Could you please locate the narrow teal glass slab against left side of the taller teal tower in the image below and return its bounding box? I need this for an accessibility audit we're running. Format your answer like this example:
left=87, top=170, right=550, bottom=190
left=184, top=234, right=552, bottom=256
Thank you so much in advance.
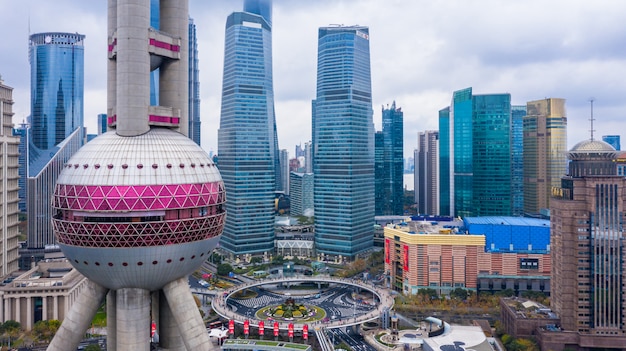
left=438, top=107, right=454, bottom=216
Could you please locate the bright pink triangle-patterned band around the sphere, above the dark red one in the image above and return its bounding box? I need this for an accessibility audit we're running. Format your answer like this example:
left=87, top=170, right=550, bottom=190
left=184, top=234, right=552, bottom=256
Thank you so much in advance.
left=52, top=182, right=225, bottom=211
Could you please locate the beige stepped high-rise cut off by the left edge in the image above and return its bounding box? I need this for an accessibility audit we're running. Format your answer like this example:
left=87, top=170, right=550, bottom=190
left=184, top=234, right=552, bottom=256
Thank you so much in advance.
left=0, top=77, right=20, bottom=276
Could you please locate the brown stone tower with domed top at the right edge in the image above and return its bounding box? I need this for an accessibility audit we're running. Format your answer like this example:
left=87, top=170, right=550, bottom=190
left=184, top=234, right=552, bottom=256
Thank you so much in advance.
left=544, top=140, right=626, bottom=350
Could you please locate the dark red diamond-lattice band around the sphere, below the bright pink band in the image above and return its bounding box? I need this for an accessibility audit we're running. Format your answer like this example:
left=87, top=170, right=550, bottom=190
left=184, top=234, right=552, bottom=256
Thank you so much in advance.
left=52, top=213, right=226, bottom=248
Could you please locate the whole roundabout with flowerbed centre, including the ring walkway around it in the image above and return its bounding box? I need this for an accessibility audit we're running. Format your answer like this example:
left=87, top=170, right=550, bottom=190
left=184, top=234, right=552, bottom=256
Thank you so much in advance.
left=211, top=275, right=394, bottom=331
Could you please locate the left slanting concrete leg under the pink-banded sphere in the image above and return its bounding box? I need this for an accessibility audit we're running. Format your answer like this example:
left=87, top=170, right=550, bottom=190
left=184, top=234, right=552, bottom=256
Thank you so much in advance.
left=48, top=280, right=109, bottom=351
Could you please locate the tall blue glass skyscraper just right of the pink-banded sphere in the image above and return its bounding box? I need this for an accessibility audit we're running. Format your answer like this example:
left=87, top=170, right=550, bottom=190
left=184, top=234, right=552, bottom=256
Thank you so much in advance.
left=218, top=0, right=282, bottom=255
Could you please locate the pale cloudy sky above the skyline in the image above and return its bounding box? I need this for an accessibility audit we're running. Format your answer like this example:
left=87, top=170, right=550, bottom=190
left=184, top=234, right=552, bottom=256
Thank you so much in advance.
left=0, top=0, right=626, bottom=160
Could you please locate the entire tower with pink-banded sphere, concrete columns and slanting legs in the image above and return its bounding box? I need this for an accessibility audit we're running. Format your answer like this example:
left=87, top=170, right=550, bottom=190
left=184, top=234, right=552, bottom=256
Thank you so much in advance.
left=48, top=0, right=226, bottom=351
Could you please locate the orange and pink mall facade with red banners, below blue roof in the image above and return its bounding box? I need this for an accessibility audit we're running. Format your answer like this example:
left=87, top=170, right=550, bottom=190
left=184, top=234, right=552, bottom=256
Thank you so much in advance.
left=384, top=221, right=551, bottom=294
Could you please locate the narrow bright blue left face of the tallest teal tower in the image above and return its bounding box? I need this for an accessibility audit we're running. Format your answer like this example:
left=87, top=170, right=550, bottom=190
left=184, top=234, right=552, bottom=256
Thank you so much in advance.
left=450, top=88, right=474, bottom=217
